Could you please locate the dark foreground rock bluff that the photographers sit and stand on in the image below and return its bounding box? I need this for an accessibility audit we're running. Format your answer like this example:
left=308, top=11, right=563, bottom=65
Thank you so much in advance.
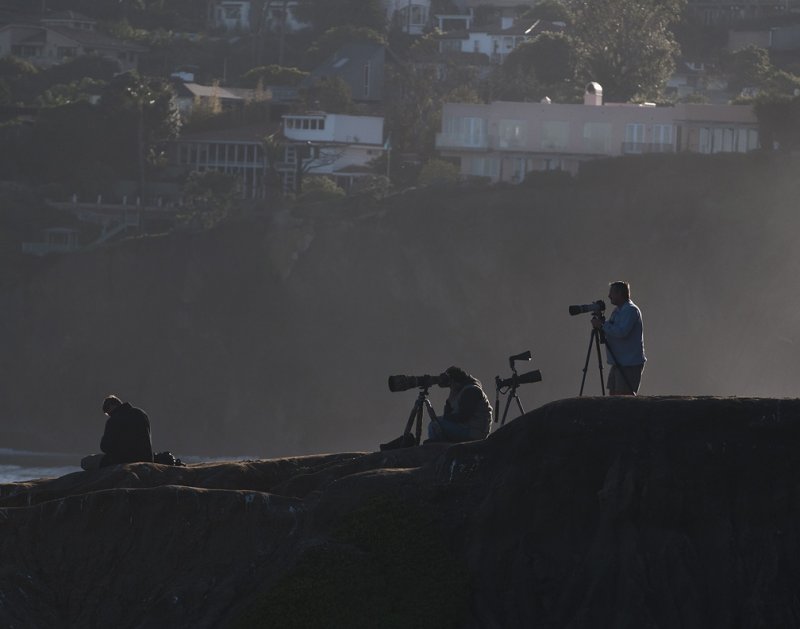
left=0, top=397, right=800, bottom=629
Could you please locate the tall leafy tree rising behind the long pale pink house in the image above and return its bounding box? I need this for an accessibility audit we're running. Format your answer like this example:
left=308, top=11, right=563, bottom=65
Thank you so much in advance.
left=569, top=0, right=684, bottom=102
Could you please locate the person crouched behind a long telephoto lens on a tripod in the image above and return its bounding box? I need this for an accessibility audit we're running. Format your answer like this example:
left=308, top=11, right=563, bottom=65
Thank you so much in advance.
left=428, top=367, right=492, bottom=442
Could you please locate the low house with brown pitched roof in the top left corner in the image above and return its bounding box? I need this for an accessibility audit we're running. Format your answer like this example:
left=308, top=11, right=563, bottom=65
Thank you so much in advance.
left=0, top=11, right=147, bottom=72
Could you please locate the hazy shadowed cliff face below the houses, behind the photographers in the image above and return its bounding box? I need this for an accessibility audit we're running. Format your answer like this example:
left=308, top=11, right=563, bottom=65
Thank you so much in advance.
left=0, top=158, right=800, bottom=457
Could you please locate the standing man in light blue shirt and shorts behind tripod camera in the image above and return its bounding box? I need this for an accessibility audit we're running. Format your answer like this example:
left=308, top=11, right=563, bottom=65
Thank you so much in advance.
left=592, top=282, right=647, bottom=395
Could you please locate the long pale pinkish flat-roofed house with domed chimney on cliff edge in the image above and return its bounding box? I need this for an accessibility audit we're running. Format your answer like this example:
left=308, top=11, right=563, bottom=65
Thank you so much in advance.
left=436, top=83, right=759, bottom=182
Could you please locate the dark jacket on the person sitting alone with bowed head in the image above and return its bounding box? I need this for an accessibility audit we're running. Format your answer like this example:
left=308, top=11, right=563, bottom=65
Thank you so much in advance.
left=100, top=402, right=153, bottom=467
